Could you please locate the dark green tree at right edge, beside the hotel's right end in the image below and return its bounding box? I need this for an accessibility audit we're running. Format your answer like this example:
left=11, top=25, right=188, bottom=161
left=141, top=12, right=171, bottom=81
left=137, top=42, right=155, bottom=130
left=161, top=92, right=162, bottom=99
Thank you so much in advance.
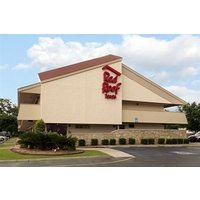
left=179, top=102, right=200, bottom=132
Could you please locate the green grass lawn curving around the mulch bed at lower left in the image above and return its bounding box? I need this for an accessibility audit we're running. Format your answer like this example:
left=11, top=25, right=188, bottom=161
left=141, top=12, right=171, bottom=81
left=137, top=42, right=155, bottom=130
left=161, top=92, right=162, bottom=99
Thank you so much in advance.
left=0, top=138, right=107, bottom=161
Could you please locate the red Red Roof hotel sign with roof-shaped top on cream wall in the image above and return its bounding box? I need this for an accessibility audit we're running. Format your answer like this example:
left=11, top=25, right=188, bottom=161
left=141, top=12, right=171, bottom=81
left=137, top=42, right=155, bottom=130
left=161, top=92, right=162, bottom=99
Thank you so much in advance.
left=102, top=65, right=122, bottom=99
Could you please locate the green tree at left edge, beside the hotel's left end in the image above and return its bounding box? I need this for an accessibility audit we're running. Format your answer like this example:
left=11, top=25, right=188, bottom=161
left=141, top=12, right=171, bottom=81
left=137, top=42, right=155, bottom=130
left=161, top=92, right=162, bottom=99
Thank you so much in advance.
left=0, top=98, right=18, bottom=133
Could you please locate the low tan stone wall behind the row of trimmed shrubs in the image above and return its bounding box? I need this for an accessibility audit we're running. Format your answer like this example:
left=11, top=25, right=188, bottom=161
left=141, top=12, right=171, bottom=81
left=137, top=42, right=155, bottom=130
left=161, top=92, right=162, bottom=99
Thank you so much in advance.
left=72, top=129, right=187, bottom=145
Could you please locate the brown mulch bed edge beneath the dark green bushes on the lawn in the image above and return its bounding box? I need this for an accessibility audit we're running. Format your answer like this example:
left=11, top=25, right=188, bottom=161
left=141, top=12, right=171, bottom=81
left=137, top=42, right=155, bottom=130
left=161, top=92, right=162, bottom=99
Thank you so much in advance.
left=11, top=146, right=84, bottom=156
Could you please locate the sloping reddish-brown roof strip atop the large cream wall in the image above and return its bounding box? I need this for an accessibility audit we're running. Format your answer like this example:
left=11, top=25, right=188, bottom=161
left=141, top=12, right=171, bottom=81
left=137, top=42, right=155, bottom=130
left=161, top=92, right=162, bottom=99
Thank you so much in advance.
left=38, top=54, right=122, bottom=81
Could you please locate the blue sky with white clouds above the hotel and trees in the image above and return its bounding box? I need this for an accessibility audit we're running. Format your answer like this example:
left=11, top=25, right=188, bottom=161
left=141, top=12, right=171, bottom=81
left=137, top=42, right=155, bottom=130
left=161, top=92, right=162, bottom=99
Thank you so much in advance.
left=0, top=34, right=200, bottom=103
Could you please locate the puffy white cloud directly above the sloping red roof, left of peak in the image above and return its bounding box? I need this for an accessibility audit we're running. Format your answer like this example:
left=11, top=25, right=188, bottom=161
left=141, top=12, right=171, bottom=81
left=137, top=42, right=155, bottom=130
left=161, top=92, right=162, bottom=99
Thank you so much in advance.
left=13, top=37, right=119, bottom=71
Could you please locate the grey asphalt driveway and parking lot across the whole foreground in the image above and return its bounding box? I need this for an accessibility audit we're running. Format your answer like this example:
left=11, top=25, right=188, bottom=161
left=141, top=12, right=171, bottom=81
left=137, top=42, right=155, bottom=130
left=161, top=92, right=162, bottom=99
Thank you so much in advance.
left=0, top=145, right=200, bottom=167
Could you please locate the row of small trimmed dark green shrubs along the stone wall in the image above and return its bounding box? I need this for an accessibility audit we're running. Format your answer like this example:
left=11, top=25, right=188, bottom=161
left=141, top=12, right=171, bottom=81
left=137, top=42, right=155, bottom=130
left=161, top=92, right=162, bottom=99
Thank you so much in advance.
left=78, top=138, right=189, bottom=146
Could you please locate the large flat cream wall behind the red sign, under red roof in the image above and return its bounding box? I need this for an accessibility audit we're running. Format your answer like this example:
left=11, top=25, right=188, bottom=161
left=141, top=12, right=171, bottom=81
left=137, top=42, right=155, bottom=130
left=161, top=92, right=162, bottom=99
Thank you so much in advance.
left=41, top=62, right=122, bottom=124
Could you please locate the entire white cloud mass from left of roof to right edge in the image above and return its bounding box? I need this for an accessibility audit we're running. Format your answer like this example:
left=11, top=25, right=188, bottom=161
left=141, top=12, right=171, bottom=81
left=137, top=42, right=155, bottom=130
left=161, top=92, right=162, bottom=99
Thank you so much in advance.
left=13, top=35, right=200, bottom=103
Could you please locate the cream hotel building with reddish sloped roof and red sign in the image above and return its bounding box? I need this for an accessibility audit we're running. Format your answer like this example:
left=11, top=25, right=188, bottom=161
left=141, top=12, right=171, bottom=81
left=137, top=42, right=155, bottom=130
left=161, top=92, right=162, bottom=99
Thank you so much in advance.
left=18, top=55, right=187, bottom=141
